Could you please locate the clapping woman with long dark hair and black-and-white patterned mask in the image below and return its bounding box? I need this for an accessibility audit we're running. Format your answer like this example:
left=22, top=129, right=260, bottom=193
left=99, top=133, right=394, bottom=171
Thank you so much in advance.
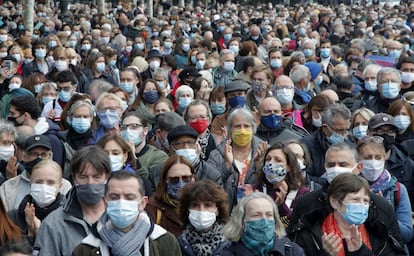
left=245, top=143, right=310, bottom=226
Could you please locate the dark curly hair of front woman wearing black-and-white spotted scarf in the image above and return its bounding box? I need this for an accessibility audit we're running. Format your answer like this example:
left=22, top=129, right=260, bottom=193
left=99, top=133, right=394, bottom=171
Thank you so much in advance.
left=179, top=180, right=229, bottom=225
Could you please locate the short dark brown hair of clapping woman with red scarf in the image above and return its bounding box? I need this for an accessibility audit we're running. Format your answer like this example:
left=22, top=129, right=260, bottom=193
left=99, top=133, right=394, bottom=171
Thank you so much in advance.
left=326, top=173, right=370, bottom=205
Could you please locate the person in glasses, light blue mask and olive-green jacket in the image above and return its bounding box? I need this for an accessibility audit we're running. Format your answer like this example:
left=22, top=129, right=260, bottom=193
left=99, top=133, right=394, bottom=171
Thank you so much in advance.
left=121, top=112, right=168, bottom=177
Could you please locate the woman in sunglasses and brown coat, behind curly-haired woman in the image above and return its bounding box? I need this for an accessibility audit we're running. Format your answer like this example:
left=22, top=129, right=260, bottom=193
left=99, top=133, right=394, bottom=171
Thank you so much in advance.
left=145, top=154, right=195, bottom=236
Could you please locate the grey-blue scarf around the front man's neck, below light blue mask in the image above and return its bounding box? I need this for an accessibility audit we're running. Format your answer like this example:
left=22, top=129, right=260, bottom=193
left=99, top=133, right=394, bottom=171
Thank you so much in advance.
left=98, top=211, right=151, bottom=256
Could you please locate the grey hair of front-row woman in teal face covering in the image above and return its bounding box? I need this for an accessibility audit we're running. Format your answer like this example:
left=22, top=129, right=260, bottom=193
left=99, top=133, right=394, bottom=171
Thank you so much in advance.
left=223, top=192, right=286, bottom=242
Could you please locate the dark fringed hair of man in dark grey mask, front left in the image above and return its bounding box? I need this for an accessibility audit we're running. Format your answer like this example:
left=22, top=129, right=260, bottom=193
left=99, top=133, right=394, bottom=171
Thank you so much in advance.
left=70, top=146, right=111, bottom=178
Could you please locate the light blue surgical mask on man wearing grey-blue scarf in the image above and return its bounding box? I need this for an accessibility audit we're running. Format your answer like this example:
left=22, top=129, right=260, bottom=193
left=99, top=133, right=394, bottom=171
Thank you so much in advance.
left=106, top=199, right=139, bottom=228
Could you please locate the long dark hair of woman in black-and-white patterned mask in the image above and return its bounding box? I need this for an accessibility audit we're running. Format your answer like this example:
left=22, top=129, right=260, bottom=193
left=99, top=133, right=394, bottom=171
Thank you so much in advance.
left=256, top=143, right=305, bottom=190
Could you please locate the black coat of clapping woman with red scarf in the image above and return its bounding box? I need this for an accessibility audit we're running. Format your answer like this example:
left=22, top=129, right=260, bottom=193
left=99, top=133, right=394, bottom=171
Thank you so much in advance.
left=287, top=187, right=405, bottom=256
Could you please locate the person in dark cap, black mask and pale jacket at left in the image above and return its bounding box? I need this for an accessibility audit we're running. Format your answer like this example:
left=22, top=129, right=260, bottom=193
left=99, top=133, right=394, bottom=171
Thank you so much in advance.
left=0, top=135, right=72, bottom=211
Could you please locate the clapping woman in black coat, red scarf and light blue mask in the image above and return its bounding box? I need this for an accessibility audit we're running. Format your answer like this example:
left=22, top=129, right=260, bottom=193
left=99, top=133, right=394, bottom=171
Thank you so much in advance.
left=288, top=173, right=406, bottom=255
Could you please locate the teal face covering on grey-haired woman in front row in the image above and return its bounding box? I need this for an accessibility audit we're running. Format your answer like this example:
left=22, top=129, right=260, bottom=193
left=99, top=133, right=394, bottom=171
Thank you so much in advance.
left=240, top=218, right=276, bottom=255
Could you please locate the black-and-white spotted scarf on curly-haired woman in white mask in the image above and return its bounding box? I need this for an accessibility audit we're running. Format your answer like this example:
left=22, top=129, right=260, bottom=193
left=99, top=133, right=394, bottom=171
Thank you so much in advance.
left=184, top=222, right=223, bottom=256
